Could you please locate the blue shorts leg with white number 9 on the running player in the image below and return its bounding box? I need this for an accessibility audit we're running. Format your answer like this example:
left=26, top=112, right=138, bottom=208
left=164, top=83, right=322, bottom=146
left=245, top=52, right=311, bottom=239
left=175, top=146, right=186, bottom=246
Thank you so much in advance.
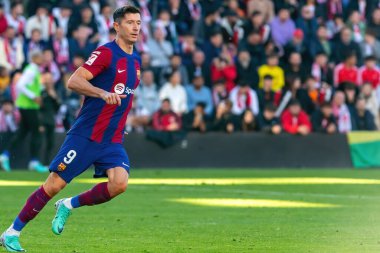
left=49, top=135, right=98, bottom=183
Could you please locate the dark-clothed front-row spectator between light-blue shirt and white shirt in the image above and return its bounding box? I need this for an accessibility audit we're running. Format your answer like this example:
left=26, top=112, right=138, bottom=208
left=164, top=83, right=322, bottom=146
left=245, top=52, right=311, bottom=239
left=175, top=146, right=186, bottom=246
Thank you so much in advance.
left=213, top=100, right=240, bottom=133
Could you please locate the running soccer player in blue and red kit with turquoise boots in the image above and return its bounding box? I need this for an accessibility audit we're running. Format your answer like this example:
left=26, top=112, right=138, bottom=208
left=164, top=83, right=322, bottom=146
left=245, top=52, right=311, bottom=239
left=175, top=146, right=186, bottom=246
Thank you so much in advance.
left=0, top=6, right=141, bottom=252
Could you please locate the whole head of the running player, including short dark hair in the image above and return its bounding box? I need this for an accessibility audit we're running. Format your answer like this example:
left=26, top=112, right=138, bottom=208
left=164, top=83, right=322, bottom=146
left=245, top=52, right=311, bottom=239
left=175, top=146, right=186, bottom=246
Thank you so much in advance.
left=113, top=5, right=141, bottom=44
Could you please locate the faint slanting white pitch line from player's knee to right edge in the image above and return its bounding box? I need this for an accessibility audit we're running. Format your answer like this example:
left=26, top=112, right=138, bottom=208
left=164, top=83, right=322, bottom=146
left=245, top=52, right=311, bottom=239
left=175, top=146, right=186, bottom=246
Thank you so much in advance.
left=130, top=185, right=380, bottom=200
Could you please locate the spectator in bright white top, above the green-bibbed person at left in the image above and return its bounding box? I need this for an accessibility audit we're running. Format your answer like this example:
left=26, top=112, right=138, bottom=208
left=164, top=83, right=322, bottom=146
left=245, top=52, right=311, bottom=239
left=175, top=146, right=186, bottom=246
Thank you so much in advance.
left=25, top=4, right=56, bottom=42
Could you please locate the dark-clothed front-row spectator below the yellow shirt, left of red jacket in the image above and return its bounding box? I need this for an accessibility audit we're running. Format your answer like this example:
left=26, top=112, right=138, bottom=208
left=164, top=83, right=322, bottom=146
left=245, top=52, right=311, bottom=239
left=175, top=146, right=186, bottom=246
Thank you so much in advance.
left=257, top=103, right=282, bottom=135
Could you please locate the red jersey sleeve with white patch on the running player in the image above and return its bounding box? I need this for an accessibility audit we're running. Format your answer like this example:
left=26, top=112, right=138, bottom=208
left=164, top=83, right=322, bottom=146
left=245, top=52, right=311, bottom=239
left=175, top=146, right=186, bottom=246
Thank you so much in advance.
left=82, top=46, right=112, bottom=77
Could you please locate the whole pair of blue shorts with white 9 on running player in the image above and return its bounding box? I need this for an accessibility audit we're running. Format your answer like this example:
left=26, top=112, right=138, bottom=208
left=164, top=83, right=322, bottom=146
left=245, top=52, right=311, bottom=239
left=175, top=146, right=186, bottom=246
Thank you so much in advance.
left=49, top=134, right=130, bottom=183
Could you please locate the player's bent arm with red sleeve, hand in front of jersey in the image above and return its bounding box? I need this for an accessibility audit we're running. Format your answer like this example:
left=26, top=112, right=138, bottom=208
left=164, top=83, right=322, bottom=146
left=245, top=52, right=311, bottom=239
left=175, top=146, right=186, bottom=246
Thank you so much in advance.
left=67, top=47, right=126, bottom=105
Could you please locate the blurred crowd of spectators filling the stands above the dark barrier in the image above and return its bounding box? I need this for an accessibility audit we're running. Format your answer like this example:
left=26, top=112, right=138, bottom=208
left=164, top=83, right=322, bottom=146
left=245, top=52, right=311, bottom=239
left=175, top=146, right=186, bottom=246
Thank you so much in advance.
left=0, top=0, right=380, bottom=142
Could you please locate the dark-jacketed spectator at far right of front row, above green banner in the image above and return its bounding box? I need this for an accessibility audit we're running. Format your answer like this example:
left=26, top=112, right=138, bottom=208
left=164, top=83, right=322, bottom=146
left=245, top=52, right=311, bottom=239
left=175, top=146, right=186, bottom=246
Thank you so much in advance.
left=353, top=97, right=376, bottom=131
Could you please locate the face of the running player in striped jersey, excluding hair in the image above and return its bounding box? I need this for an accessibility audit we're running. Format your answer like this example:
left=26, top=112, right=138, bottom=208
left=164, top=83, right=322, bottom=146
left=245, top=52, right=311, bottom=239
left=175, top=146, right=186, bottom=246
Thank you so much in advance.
left=114, top=13, right=141, bottom=44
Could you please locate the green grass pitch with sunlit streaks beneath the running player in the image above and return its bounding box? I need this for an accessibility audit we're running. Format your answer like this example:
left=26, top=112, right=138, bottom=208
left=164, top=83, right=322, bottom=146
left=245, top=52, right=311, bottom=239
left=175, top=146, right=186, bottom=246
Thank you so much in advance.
left=0, top=169, right=380, bottom=253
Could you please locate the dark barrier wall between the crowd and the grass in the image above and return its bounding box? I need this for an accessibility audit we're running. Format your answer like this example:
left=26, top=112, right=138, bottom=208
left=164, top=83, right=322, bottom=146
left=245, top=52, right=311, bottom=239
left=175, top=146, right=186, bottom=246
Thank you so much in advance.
left=5, top=133, right=352, bottom=168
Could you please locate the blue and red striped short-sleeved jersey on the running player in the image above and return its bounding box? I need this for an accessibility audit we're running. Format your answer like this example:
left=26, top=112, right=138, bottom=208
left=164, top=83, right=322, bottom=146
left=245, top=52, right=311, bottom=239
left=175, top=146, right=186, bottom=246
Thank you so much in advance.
left=68, top=41, right=141, bottom=143
